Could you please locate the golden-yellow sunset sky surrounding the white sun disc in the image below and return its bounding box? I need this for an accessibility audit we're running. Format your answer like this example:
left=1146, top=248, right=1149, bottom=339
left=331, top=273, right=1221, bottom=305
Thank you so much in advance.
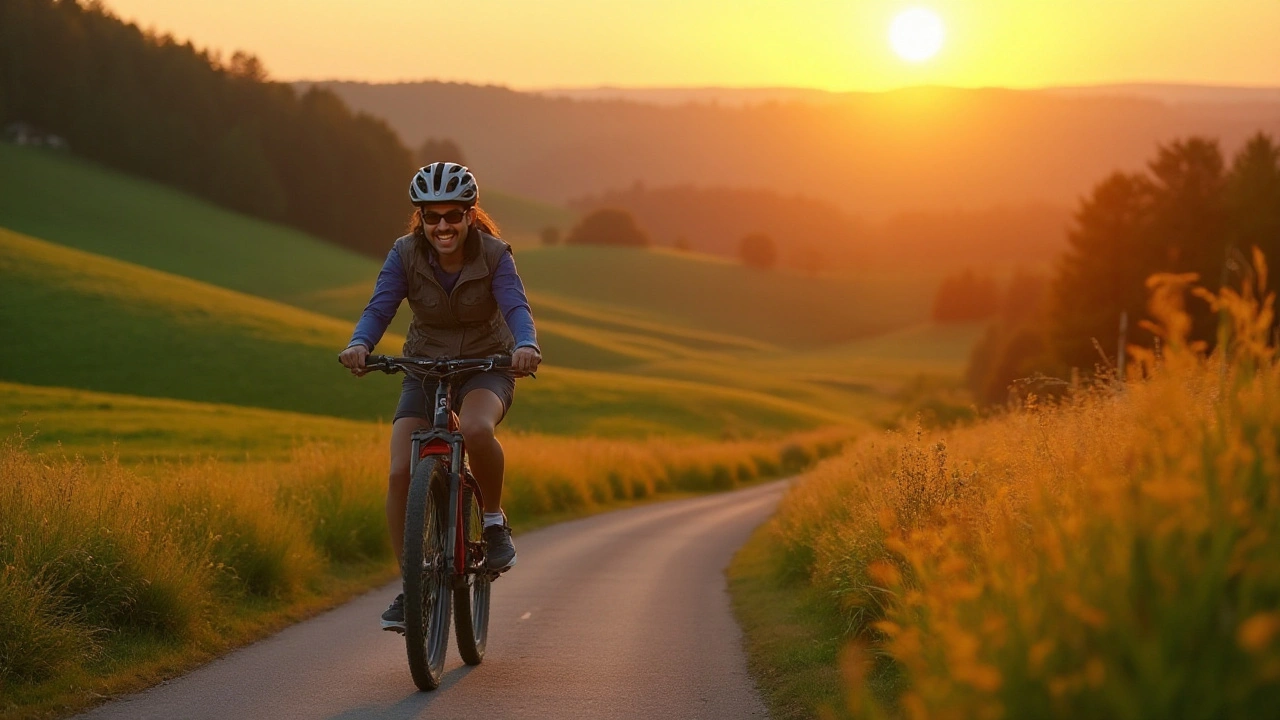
left=105, top=0, right=1280, bottom=91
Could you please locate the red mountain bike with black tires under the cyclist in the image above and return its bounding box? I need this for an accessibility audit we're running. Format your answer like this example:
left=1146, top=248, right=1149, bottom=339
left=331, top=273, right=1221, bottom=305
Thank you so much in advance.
left=365, top=355, right=511, bottom=691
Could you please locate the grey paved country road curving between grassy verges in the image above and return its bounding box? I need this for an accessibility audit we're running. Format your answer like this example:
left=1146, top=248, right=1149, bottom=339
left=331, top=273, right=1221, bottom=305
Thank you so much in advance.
left=82, top=483, right=785, bottom=720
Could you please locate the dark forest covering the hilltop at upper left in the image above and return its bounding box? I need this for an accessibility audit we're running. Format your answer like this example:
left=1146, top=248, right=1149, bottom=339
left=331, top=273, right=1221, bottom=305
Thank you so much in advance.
left=0, top=0, right=415, bottom=255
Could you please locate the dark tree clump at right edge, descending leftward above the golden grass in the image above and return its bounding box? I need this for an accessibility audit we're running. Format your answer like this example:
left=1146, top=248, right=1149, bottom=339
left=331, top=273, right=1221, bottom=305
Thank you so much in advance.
left=968, top=133, right=1280, bottom=404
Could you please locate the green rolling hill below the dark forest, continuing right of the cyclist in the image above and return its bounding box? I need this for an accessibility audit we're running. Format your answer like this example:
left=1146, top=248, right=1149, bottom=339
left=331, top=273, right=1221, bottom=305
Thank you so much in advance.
left=0, top=143, right=936, bottom=353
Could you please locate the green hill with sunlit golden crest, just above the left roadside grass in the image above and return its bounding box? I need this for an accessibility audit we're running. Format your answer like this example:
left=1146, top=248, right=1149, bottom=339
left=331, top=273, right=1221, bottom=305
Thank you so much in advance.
left=0, top=231, right=833, bottom=437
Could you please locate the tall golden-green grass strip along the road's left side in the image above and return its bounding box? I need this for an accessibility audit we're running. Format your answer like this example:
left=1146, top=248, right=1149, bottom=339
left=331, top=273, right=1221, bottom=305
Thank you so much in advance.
left=0, top=422, right=847, bottom=688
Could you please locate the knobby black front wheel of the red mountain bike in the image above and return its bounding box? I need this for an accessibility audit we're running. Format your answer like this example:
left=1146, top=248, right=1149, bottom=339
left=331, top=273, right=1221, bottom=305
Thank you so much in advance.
left=402, top=460, right=453, bottom=691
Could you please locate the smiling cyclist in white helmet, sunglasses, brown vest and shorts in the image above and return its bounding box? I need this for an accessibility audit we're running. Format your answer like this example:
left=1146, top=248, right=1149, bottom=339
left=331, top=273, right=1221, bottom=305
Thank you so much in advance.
left=339, top=163, right=541, bottom=630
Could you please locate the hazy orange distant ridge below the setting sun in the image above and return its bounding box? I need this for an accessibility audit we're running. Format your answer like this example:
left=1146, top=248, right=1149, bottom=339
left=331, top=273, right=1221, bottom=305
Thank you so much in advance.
left=296, top=82, right=1280, bottom=222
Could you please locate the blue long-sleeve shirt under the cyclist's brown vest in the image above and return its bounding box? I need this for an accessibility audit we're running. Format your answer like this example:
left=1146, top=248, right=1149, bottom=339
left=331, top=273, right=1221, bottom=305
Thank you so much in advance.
left=347, top=247, right=538, bottom=352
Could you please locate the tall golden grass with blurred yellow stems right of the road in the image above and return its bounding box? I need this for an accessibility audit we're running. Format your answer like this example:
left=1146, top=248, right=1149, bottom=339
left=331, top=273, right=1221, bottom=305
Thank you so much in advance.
left=774, top=249, right=1280, bottom=719
